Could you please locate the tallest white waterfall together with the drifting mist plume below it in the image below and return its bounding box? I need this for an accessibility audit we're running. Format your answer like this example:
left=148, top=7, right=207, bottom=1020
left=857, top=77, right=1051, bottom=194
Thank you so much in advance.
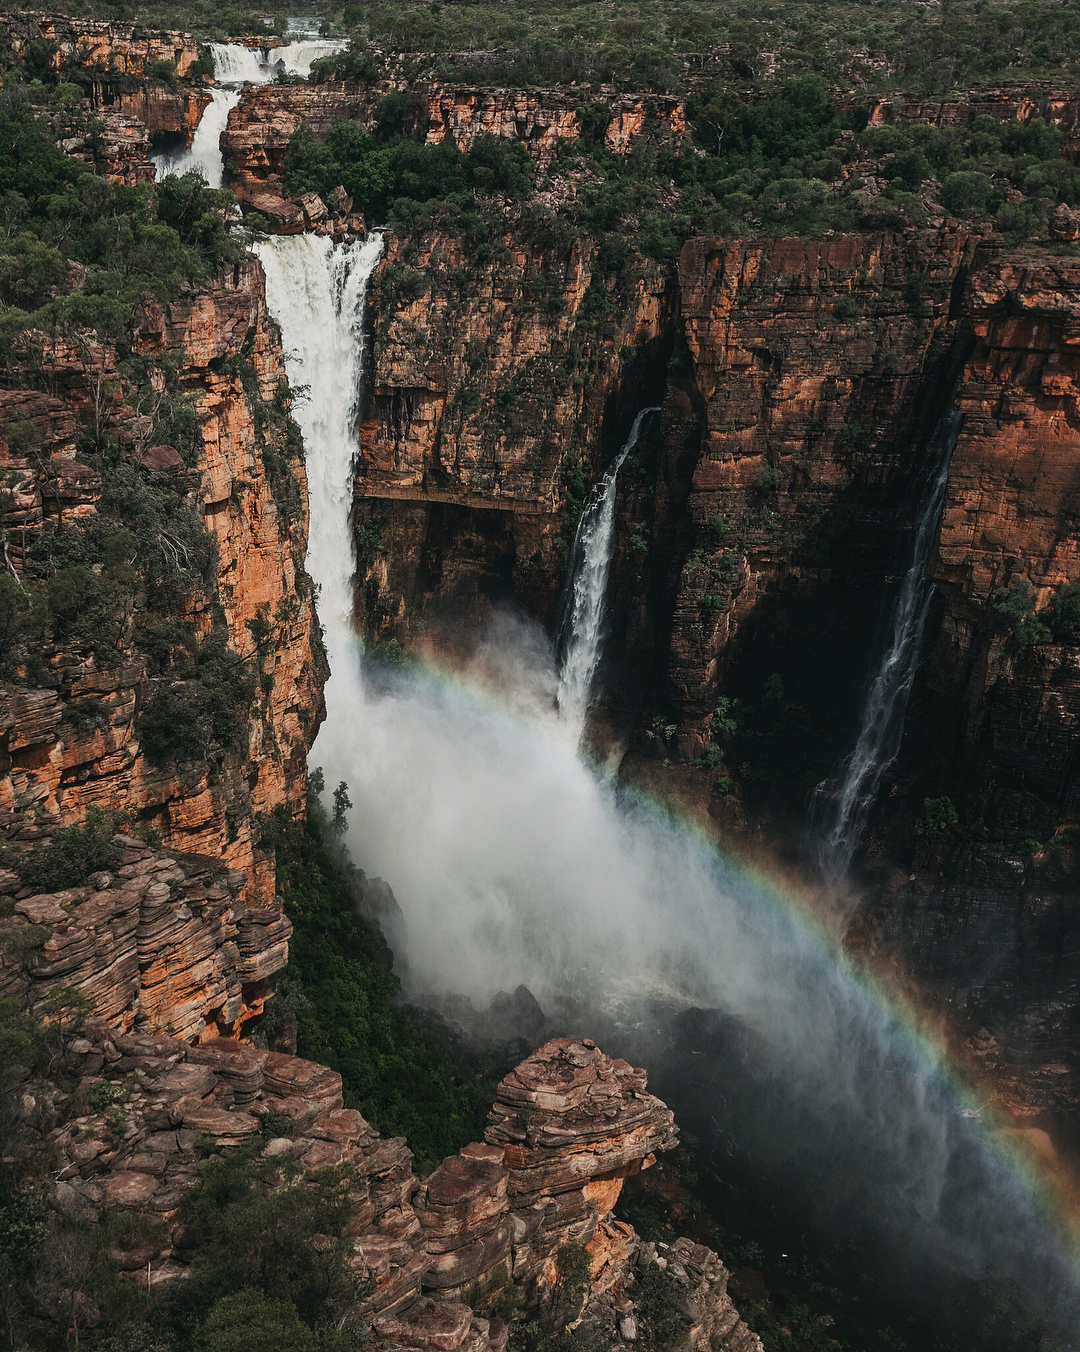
left=258, top=237, right=1076, bottom=1335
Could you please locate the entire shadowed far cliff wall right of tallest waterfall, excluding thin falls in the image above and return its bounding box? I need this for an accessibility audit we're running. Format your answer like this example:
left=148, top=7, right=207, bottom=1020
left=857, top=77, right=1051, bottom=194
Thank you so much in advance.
left=357, top=222, right=1080, bottom=1117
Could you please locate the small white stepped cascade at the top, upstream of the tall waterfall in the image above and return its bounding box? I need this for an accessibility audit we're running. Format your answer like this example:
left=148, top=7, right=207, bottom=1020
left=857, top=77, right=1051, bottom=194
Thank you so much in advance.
left=150, top=38, right=345, bottom=188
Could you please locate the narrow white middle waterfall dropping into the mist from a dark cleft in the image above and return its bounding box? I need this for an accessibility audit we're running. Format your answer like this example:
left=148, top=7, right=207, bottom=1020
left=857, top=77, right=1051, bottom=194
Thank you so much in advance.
left=557, top=406, right=660, bottom=741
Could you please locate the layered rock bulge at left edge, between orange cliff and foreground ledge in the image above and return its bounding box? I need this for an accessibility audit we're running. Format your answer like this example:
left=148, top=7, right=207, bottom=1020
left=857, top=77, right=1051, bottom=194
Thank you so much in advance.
left=0, top=813, right=292, bottom=1041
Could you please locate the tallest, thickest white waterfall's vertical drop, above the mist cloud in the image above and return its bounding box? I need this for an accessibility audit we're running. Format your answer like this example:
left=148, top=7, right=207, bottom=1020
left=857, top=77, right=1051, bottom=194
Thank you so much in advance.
left=254, top=233, right=383, bottom=779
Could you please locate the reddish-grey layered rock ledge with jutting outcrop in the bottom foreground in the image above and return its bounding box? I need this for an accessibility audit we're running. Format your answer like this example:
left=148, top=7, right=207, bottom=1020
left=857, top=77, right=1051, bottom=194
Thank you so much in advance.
left=24, top=1019, right=761, bottom=1352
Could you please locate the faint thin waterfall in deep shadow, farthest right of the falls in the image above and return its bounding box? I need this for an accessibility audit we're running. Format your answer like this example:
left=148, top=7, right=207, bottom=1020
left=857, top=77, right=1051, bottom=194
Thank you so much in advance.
left=815, top=412, right=961, bottom=882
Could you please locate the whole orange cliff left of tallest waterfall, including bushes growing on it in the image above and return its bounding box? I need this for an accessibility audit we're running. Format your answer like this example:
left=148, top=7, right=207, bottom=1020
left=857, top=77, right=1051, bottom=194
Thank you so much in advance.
left=0, top=258, right=323, bottom=896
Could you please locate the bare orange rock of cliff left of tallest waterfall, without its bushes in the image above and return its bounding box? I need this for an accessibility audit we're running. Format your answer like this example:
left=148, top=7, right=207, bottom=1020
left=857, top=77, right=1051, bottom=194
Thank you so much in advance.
left=0, top=260, right=323, bottom=898
